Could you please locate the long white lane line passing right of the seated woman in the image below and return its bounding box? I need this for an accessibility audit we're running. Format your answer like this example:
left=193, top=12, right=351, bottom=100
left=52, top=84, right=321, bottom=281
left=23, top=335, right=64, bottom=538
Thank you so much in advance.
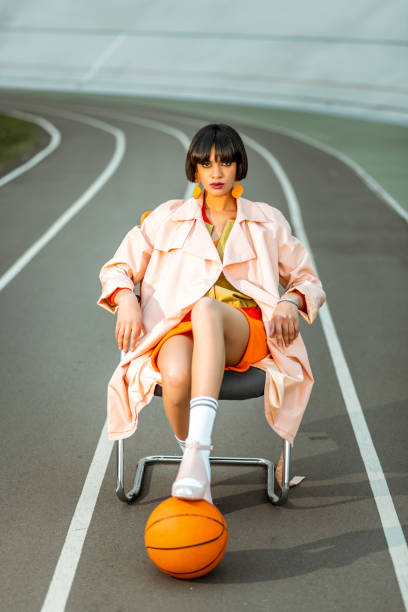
left=241, top=132, right=408, bottom=609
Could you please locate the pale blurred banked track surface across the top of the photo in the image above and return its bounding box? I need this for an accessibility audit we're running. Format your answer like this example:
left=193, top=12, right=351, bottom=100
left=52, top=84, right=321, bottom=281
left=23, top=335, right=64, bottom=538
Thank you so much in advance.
left=0, top=0, right=408, bottom=123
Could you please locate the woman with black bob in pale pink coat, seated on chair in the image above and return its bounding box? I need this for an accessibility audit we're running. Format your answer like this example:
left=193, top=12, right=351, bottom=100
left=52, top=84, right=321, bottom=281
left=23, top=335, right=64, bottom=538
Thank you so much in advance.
left=98, top=124, right=325, bottom=503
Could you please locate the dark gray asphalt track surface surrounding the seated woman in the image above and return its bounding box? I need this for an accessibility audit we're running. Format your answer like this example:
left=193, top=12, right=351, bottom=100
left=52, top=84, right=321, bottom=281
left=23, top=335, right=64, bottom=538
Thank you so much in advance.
left=0, top=94, right=408, bottom=612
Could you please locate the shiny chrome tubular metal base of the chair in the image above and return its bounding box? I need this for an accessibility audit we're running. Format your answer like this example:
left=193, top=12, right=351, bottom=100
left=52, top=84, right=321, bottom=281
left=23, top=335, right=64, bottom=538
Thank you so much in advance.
left=116, top=440, right=291, bottom=506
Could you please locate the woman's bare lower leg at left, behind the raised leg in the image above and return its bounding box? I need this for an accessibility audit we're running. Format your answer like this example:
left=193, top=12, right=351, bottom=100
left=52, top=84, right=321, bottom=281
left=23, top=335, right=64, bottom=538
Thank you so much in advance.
left=157, top=334, right=193, bottom=440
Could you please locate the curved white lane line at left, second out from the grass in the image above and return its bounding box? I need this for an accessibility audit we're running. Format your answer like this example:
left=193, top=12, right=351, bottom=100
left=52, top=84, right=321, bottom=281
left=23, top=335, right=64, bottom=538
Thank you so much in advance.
left=0, top=107, right=126, bottom=291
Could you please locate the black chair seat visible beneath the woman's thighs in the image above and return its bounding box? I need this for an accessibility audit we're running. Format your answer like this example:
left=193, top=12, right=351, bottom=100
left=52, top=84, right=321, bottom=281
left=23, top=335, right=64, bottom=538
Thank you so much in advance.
left=154, top=366, right=265, bottom=400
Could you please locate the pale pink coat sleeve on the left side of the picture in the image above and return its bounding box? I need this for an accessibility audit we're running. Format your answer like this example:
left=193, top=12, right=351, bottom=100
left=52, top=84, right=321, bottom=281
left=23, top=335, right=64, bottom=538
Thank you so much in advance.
left=97, top=219, right=153, bottom=313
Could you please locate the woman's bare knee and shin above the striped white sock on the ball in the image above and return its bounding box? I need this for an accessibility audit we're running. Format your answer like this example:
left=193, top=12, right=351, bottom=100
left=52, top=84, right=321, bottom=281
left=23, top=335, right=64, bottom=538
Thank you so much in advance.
left=191, top=297, right=249, bottom=398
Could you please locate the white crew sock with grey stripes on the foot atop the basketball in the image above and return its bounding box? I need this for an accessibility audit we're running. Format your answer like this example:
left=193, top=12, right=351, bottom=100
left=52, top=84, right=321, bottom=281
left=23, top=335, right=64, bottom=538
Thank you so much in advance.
left=186, top=395, right=218, bottom=482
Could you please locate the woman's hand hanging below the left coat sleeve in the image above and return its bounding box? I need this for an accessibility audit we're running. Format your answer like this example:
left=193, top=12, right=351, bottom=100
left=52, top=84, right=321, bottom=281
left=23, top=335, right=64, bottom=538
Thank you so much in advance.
left=115, top=289, right=143, bottom=353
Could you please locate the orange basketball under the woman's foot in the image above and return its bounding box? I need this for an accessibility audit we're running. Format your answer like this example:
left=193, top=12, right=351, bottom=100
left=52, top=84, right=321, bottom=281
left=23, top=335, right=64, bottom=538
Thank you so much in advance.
left=145, top=497, right=228, bottom=578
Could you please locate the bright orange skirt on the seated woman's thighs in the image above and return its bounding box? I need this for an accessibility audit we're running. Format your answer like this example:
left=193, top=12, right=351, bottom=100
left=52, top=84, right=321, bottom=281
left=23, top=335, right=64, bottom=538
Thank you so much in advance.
left=151, top=306, right=269, bottom=372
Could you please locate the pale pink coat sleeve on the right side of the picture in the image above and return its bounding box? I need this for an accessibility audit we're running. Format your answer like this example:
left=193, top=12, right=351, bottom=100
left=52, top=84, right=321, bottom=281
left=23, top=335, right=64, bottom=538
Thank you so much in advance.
left=279, top=214, right=326, bottom=324
